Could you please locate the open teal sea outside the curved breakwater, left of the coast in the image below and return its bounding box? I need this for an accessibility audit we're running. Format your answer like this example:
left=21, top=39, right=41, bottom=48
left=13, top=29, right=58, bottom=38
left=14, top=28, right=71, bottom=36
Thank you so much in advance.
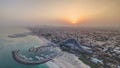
left=0, top=28, right=48, bottom=68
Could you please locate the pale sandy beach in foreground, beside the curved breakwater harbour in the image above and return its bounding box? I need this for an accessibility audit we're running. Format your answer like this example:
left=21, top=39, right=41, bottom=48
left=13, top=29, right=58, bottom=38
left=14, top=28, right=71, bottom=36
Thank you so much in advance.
left=46, top=52, right=90, bottom=68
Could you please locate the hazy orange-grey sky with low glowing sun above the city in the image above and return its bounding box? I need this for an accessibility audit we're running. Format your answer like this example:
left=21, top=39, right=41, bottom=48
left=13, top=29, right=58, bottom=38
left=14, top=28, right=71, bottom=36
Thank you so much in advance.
left=0, top=0, right=120, bottom=27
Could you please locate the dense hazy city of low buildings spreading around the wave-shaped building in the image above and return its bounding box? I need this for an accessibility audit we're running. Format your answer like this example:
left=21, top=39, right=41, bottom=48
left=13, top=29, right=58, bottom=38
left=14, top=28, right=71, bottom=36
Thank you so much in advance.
left=29, top=27, right=120, bottom=68
